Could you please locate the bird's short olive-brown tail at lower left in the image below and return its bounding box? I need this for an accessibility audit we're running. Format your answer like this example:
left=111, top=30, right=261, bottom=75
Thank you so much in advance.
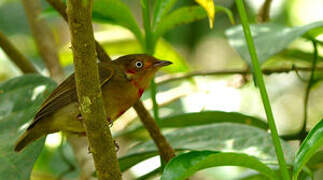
left=15, top=128, right=45, bottom=152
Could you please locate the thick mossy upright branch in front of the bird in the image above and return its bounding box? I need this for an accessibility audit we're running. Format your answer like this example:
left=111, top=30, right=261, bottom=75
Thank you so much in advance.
left=67, top=0, right=121, bottom=180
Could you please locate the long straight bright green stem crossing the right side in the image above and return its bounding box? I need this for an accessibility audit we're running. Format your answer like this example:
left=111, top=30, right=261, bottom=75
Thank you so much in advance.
left=235, top=0, right=290, bottom=180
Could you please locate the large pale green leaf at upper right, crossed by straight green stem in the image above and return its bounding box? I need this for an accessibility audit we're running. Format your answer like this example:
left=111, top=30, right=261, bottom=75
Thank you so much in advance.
left=226, top=21, right=323, bottom=64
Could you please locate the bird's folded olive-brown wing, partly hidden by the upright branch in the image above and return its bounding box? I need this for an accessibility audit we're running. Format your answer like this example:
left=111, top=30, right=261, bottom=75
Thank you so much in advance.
left=28, top=63, right=114, bottom=129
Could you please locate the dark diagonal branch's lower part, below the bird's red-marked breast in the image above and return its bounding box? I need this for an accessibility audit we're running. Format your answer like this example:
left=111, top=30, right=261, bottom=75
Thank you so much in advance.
left=133, top=101, right=175, bottom=162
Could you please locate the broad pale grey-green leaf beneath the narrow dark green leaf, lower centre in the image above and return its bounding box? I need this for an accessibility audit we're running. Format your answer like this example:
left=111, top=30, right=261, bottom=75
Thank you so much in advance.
left=120, top=123, right=294, bottom=170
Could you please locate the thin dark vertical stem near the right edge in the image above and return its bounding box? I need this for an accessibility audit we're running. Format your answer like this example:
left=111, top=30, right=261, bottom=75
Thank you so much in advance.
left=300, top=41, right=318, bottom=141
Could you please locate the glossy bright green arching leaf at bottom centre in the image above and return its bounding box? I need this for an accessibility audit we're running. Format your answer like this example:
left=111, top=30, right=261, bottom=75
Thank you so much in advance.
left=160, top=151, right=279, bottom=180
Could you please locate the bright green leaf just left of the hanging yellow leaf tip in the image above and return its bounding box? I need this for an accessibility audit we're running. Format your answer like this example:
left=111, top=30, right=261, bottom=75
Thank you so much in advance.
left=154, top=6, right=207, bottom=40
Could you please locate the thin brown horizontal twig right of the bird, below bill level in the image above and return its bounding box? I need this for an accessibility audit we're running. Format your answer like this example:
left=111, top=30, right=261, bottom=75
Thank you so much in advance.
left=156, top=66, right=323, bottom=85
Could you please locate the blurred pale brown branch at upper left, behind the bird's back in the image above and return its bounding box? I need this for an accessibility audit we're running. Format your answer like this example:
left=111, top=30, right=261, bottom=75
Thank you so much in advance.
left=22, top=0, right=64, bottom=82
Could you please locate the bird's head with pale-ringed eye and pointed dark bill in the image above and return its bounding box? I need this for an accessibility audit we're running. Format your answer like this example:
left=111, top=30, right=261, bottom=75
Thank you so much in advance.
left=115, top=54, right=172, bottom=89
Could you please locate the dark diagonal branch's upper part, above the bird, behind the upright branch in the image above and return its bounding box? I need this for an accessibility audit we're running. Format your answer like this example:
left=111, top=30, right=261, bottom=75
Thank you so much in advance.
left=47, top=0, right=111, bottom=62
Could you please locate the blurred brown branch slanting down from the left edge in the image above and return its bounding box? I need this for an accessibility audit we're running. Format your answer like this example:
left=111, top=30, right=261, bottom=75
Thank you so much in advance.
left=0, top=31, right=38, bottom=73
